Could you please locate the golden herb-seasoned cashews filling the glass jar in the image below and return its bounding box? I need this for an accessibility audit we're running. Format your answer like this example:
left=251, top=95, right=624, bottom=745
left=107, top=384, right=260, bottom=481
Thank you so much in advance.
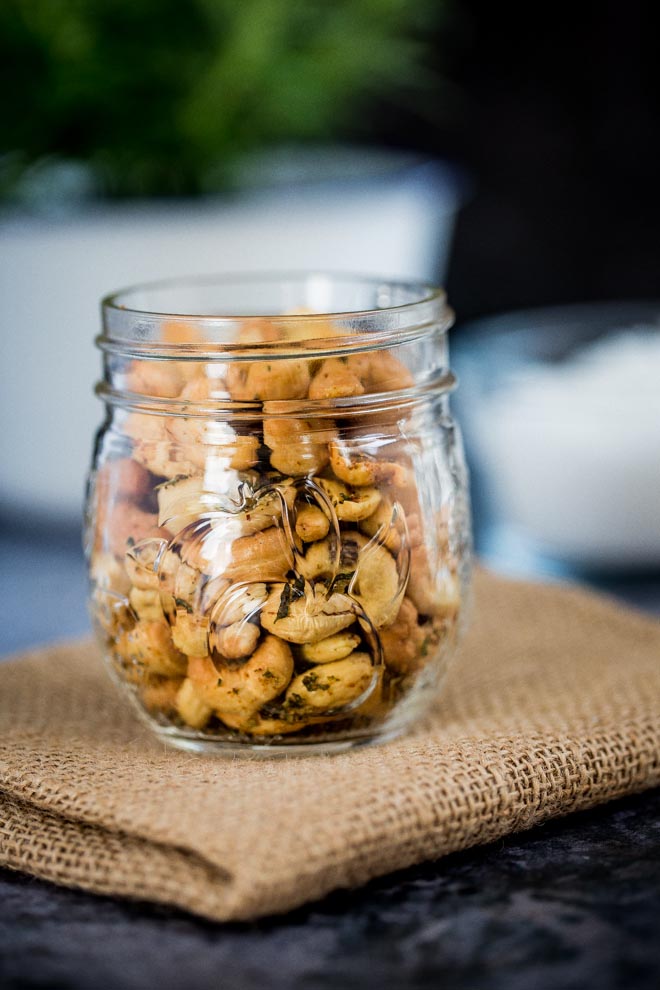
left=88, top=320, right=460, bottom=739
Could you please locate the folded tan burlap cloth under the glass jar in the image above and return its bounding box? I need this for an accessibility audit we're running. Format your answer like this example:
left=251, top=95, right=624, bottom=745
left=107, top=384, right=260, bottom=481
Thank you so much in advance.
left=0, top=574, right=660, bottom=919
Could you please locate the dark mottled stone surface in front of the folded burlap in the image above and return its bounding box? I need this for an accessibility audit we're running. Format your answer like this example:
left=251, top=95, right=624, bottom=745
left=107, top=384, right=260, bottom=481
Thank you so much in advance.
left=0, top=791, right=660, bottom=990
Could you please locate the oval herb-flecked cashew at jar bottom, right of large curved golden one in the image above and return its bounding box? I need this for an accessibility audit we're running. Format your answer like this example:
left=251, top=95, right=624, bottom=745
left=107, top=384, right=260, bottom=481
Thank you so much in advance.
left=284, top=653, right=374, bottom=712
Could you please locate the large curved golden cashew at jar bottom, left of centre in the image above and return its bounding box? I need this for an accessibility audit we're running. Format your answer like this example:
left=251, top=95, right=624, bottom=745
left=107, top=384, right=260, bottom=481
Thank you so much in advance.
left=188, top=636, right=293, bottom=718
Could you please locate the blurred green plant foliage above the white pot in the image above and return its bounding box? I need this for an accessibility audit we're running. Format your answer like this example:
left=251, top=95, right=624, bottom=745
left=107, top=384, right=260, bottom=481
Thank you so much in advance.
left=0, top=0, right=446, bottom=196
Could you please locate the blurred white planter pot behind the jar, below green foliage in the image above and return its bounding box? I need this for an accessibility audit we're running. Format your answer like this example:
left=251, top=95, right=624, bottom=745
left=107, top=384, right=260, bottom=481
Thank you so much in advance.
left=0, top=156, right=458, bottom=520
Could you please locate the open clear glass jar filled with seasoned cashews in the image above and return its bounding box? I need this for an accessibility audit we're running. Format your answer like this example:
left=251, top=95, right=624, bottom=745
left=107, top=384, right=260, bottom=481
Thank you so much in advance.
left=85, top=274, right=471, bottom=753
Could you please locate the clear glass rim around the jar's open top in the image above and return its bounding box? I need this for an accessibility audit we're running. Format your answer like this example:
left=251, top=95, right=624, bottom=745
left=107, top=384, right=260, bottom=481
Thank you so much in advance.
left=98, top=270, right=453, bottom=359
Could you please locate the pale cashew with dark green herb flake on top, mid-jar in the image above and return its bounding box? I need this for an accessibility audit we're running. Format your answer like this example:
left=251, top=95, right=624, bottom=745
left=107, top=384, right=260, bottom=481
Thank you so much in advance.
left=261, top=585, right=356, bottom=643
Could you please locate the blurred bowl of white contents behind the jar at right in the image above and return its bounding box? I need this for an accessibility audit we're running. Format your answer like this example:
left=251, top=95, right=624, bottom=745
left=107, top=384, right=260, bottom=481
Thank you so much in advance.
left=452, top=302, right=660, bottom=572
